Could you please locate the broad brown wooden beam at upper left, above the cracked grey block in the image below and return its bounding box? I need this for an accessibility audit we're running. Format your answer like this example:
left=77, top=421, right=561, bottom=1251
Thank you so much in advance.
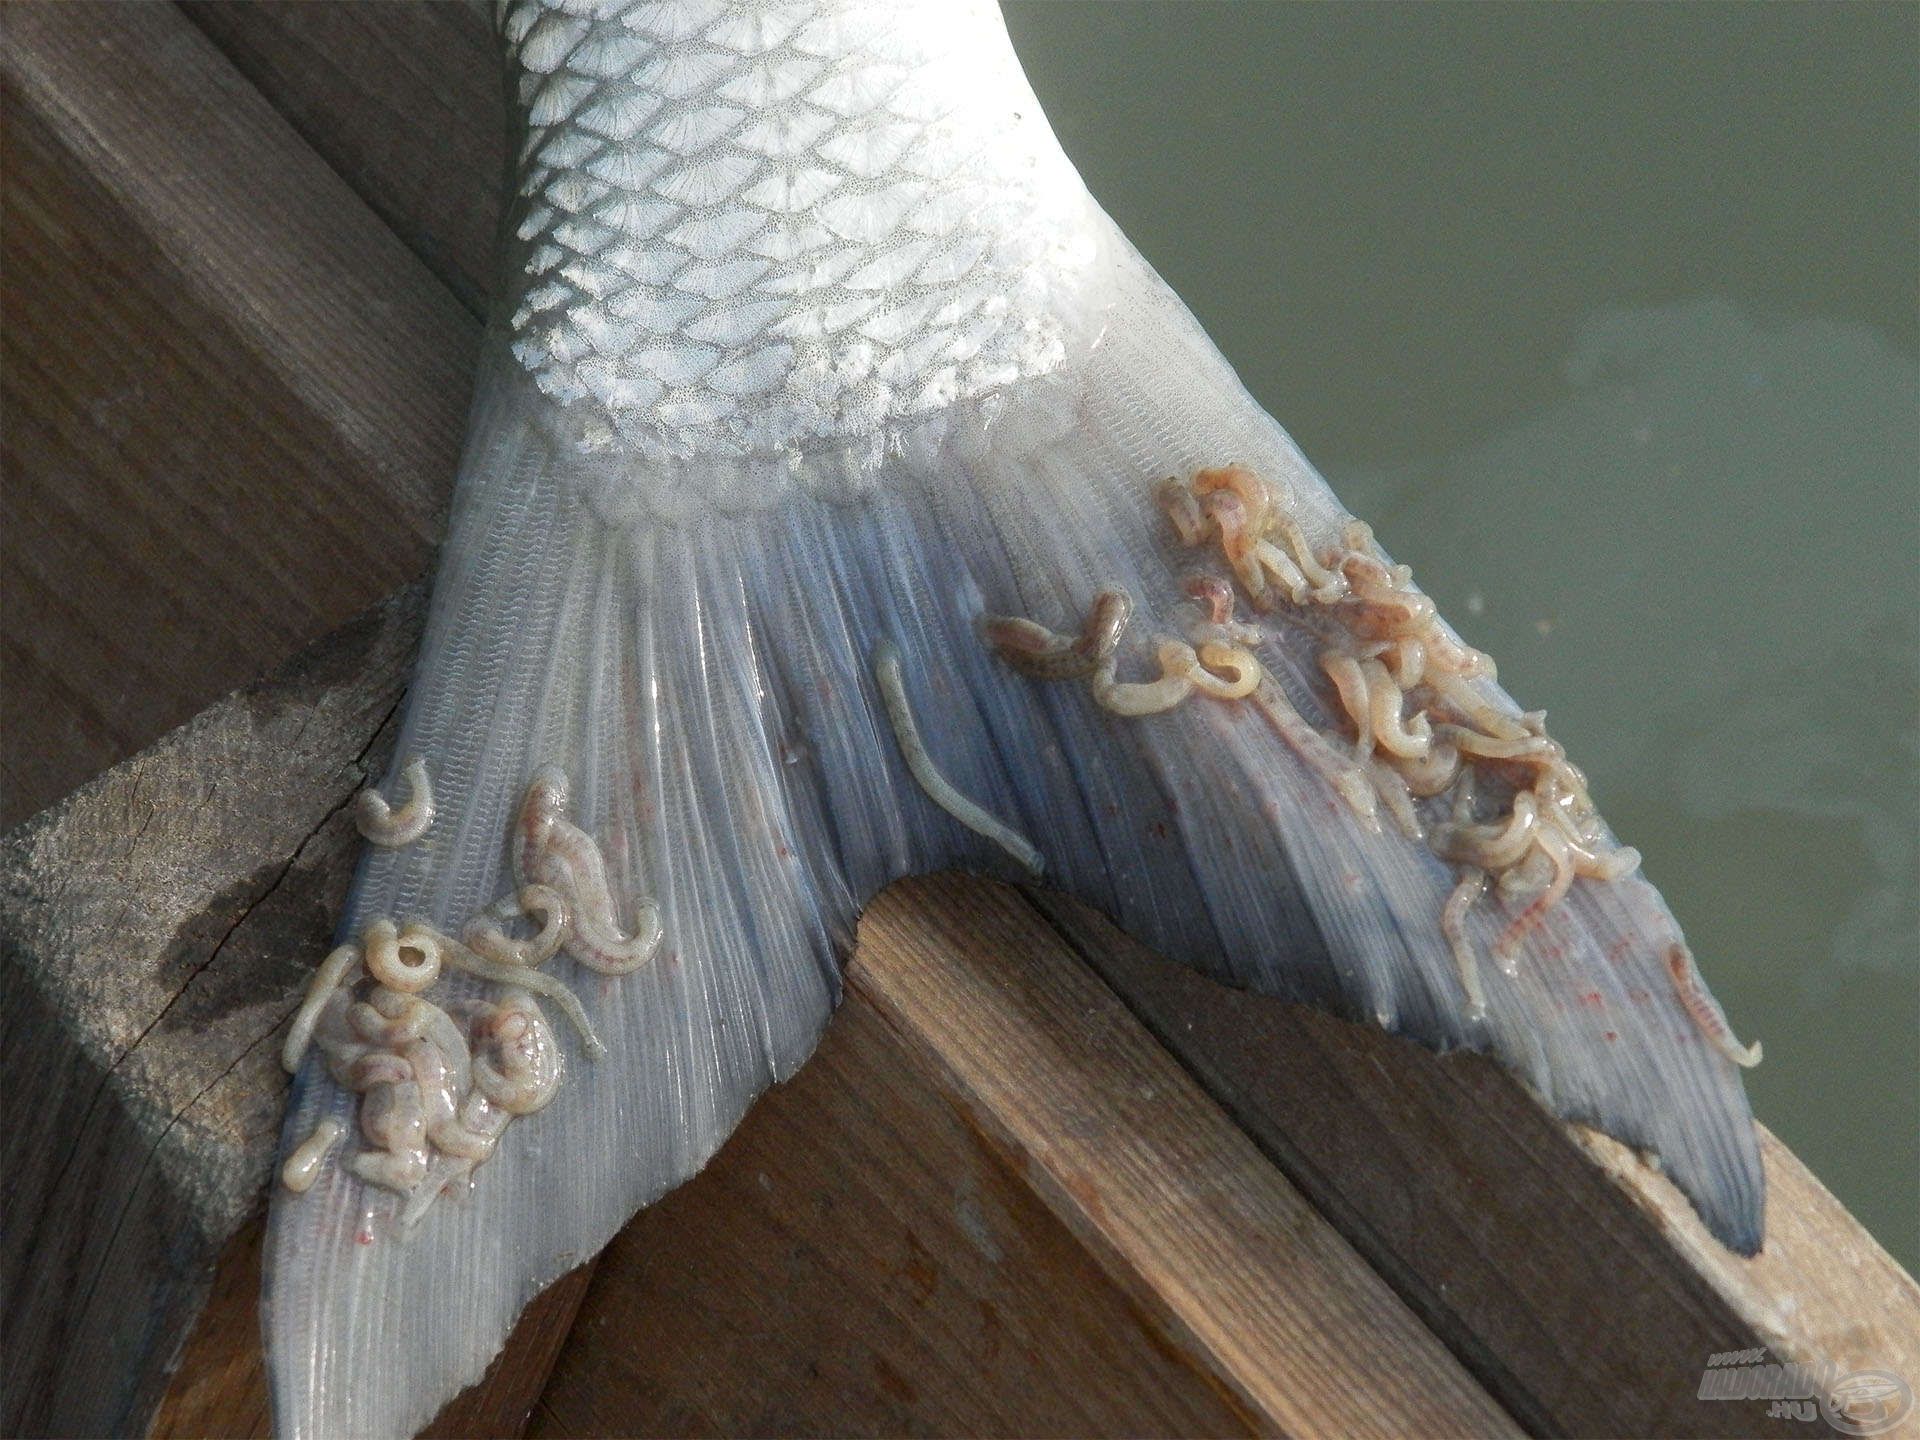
left=0, top=4, right=478, bottom=824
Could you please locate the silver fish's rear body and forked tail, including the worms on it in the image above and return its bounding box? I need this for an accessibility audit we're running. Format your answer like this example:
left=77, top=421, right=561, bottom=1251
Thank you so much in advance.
left=263, top=0, right=1764, bottom=1436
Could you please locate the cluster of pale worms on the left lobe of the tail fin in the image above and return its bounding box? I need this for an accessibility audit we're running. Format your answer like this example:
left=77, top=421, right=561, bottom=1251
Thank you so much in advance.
left=280, top=760, right=660, bottom=1225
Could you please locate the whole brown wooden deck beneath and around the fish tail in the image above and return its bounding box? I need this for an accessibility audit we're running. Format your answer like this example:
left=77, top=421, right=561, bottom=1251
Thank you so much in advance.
left=0, top=0, right=1920, bottom=1436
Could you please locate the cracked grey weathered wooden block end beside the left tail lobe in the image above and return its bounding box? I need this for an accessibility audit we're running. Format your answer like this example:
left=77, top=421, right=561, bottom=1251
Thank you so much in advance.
left=0, top=589, right=422, bottom=1434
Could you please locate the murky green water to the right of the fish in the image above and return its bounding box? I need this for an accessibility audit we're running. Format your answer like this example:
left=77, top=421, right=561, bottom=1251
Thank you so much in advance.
left=1008, top=0, right=1920, bottom=1269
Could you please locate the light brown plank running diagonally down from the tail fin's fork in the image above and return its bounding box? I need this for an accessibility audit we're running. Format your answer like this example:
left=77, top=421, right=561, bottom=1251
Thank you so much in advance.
left=851, top=876, right=1513, bottom=1436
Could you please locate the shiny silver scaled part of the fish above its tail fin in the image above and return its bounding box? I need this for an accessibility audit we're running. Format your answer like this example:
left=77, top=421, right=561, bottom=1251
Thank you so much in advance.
left=501, top=0, right=1091, bottom=455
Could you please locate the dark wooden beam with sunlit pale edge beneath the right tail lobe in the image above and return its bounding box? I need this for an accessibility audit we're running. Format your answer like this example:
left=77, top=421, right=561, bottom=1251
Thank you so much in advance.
left=1035, top=895, right=1920, bottom=1436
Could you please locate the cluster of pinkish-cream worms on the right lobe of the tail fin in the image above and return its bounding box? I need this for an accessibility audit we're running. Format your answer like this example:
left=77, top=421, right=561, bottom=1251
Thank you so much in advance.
left=983, top=465, right=1757, bottom=1064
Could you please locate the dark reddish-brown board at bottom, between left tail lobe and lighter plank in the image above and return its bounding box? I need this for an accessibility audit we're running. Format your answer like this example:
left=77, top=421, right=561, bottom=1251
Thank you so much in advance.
left=532, top=971, right=1260, bottom=1436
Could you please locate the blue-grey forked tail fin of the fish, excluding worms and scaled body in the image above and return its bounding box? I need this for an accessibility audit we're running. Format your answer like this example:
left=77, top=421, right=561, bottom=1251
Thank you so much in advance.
left=265, top=259, right=1763, bottom=1436
